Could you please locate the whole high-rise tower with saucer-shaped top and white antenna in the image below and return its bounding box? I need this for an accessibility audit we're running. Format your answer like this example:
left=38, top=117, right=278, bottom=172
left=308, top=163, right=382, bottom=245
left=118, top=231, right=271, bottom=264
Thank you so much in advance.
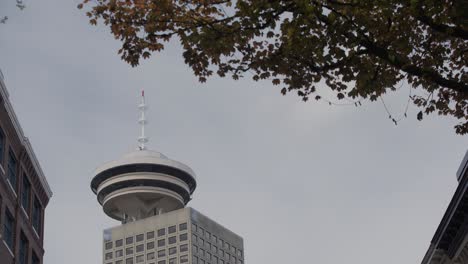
left=91, top=93, right=244, bottom=264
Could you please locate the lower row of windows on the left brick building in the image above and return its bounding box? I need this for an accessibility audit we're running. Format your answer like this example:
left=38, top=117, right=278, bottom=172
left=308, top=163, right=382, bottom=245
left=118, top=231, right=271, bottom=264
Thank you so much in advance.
left=0, top=197, right=40, bottom=264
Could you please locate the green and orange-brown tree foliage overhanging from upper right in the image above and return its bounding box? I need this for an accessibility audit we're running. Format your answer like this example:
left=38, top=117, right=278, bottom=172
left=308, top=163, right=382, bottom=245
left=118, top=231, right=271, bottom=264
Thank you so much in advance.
left=79, top=0, right=468, bottom=134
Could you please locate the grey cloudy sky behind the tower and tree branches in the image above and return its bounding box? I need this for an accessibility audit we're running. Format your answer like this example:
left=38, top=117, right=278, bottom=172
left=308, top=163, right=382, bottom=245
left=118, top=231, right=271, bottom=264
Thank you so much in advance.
left=0, top=0, right=468, bottom=264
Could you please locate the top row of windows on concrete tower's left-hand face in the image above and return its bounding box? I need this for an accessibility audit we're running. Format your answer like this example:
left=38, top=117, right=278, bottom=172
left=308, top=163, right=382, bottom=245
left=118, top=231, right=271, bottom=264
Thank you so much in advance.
left=104, top=223, right=187, bottom=250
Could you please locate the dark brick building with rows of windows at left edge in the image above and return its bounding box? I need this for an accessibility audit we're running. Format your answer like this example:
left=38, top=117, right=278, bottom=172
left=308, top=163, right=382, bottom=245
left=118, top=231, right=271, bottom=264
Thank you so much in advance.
left=0, top=73, right=52, bottom=264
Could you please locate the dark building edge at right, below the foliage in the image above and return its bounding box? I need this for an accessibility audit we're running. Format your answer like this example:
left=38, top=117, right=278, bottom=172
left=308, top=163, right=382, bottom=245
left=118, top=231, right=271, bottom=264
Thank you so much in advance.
left=422, top=151, right=468, bottom=264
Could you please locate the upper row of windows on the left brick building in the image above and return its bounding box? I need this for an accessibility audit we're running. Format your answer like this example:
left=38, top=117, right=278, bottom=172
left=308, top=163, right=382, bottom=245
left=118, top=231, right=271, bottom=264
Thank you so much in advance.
left=0, top=128, right=42, bottom=235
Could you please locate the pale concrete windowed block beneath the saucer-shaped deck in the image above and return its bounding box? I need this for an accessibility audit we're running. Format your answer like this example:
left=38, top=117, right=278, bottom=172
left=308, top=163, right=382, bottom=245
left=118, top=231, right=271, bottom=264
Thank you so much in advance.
left=103, top=207, right=244, bottom=264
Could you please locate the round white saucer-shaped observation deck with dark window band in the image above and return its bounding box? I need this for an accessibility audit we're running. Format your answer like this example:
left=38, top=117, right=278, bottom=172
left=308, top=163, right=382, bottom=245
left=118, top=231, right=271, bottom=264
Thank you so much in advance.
left=91, top=149, right=196, bottom=222
